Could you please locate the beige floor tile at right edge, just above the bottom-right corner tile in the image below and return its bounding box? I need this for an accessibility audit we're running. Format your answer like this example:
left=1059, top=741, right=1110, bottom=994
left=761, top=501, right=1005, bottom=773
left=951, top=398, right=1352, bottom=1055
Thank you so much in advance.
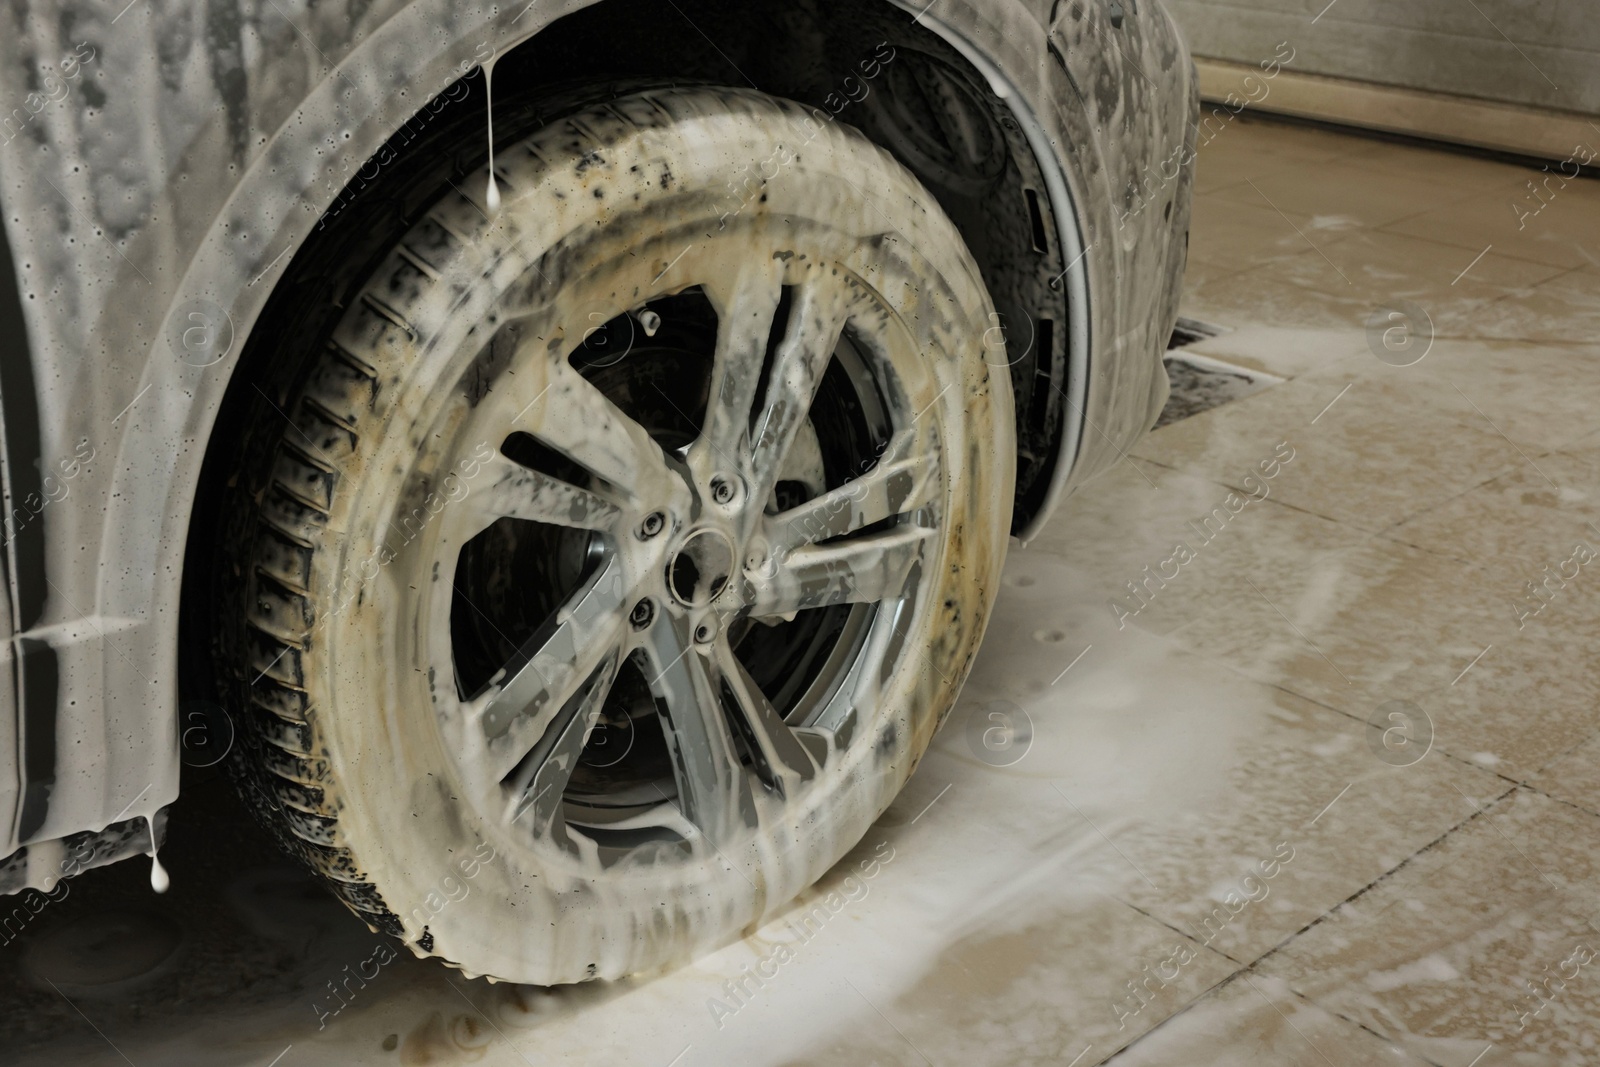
left=1138, top=492, right=1600, bottom=779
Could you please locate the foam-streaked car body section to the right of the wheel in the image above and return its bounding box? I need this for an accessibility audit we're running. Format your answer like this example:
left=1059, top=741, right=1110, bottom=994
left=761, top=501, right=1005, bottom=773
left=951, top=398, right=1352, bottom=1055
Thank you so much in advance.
left=893, top=0, right=1200, bottom=544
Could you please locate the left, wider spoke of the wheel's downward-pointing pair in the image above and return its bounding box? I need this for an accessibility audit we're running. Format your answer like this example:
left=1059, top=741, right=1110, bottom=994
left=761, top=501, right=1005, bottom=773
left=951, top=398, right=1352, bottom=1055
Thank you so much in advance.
left=645, top=616, right=755, bottom=845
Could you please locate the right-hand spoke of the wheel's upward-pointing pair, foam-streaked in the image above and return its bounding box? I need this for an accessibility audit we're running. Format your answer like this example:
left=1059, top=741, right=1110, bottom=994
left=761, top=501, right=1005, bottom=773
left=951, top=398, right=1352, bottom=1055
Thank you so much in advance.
left=750, top=277, right=848, bottom=511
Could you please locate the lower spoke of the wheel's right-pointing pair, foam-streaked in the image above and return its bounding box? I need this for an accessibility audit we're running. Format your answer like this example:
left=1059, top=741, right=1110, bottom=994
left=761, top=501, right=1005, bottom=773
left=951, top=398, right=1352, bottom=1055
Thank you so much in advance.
left=746, top=526, right=933, bottom=617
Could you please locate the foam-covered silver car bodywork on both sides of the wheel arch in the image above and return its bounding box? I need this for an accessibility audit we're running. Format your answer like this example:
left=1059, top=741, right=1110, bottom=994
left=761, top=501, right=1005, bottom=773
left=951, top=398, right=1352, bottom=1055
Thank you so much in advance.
left=0, top=0, right=1195, bottom=891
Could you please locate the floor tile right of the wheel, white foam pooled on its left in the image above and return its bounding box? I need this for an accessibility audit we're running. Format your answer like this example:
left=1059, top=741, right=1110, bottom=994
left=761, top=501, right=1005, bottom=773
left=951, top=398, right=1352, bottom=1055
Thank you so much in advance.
left=960, top=550, right=1510, bottom=963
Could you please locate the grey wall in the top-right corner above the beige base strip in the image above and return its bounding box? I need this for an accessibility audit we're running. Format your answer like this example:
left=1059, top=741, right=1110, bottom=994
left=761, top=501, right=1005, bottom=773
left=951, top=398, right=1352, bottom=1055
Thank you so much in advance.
left=1165, top=0, right=1600, bottom=115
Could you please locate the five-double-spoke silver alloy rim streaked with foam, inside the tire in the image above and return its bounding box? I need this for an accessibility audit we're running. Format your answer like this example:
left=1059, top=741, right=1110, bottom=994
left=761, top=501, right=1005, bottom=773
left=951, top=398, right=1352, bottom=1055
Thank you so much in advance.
left=400, top=235, right=944, bottom=867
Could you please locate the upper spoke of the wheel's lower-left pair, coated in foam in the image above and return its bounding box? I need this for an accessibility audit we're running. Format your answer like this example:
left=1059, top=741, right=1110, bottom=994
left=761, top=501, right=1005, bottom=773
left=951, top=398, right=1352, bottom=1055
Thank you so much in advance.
left=477, top=557, right=626, bottom=782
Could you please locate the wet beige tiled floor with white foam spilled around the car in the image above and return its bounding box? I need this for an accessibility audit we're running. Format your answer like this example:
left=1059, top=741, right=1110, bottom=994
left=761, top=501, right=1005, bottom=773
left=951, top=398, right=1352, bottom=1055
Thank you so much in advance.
left=12, top=118, right=1600, bottom=1067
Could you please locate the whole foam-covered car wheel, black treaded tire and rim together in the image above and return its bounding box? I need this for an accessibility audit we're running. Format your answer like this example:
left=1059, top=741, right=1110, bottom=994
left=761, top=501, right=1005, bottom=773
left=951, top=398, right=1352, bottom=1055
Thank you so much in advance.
left=219, top=88, right=1014, bottom=984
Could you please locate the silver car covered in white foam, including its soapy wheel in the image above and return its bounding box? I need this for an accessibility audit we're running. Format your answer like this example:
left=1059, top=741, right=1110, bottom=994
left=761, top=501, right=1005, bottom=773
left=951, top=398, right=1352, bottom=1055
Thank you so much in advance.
left=0, top=0, right=1198, bottom=984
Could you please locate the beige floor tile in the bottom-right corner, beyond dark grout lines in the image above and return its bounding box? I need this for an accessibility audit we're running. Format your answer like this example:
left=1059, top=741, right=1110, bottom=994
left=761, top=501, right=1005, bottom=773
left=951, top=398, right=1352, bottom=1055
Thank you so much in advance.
left=1261, top=790, right=1600, bottom=1067
